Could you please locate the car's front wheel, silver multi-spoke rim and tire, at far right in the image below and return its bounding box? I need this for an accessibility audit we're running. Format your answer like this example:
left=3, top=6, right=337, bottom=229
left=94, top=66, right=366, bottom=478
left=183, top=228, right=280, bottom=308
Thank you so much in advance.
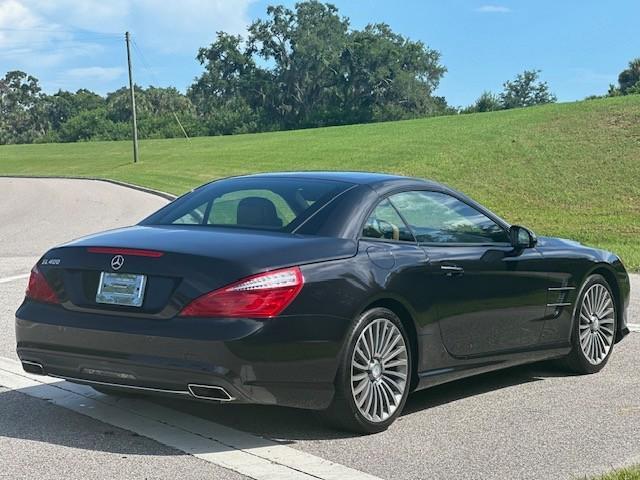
left=566, top=275, right=617, bottom=374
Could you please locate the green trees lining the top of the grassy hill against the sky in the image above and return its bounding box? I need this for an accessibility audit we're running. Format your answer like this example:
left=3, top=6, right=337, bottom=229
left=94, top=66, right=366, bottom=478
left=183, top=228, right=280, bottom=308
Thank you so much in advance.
left=0, top=0, right=640, bottom=144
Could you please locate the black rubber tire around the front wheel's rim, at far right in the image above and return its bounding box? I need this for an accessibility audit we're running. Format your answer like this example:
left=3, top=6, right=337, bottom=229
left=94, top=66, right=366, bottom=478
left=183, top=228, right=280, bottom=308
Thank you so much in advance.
left=564, top=274, right=618, bottom=375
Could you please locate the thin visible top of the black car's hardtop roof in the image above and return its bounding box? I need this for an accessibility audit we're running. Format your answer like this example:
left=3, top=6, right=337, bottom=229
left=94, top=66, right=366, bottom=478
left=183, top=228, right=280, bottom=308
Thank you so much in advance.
left=234, top=171, right=444, bottom=188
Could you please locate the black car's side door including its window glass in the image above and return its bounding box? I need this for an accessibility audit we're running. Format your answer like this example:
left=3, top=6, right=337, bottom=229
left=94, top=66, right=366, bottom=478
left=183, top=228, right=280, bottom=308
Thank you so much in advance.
left=389, top=190, right=548, bottom=357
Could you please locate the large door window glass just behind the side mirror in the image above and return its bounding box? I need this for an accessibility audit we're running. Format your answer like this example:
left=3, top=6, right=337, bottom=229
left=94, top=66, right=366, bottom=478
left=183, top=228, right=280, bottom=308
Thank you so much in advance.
left=391, top=191, right=509, bottom=243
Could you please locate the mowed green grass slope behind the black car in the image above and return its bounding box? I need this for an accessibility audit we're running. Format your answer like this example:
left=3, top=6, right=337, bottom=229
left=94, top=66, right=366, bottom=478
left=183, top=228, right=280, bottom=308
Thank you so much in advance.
left=0, top=95, right=640, bottom=270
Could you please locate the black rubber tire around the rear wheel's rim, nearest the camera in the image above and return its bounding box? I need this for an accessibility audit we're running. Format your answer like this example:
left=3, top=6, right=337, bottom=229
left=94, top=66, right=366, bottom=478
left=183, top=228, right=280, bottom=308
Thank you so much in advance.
left=320, top=308, right=413, bottom=434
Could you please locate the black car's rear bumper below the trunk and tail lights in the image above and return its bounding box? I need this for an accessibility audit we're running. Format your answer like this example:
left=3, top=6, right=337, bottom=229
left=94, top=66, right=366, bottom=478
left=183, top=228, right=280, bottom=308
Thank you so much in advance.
left=16, top=301, right=350, bottom=409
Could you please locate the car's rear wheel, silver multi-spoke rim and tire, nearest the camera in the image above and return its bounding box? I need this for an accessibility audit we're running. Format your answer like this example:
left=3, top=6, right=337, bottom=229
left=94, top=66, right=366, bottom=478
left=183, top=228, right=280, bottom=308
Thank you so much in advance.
left=323, top=308, right=412, bottom=433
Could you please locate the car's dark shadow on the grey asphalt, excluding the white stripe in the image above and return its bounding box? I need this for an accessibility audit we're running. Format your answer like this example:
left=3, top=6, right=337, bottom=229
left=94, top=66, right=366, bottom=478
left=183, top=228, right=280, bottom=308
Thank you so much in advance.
left=0, top=362, right=570, bottom=455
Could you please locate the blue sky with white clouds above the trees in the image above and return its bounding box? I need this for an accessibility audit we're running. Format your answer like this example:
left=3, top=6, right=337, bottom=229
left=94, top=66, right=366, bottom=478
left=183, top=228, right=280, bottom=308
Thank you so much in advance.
left=0, top=0, right=640, bottom=106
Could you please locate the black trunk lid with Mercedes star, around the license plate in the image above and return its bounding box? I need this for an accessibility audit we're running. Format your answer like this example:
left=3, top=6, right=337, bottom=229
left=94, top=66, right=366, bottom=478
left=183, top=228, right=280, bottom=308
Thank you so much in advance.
left=39, top=226, right=357, bottom=319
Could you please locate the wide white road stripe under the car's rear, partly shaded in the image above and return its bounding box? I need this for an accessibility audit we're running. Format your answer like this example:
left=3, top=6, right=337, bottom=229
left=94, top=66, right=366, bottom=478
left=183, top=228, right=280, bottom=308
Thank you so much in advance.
left=0, top=357, right=379, bottom=480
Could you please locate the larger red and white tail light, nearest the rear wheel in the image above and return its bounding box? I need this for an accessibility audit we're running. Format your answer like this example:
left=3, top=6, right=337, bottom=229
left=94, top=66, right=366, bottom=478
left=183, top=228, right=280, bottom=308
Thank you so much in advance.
left=180, top=267, right=304, bottom=318
